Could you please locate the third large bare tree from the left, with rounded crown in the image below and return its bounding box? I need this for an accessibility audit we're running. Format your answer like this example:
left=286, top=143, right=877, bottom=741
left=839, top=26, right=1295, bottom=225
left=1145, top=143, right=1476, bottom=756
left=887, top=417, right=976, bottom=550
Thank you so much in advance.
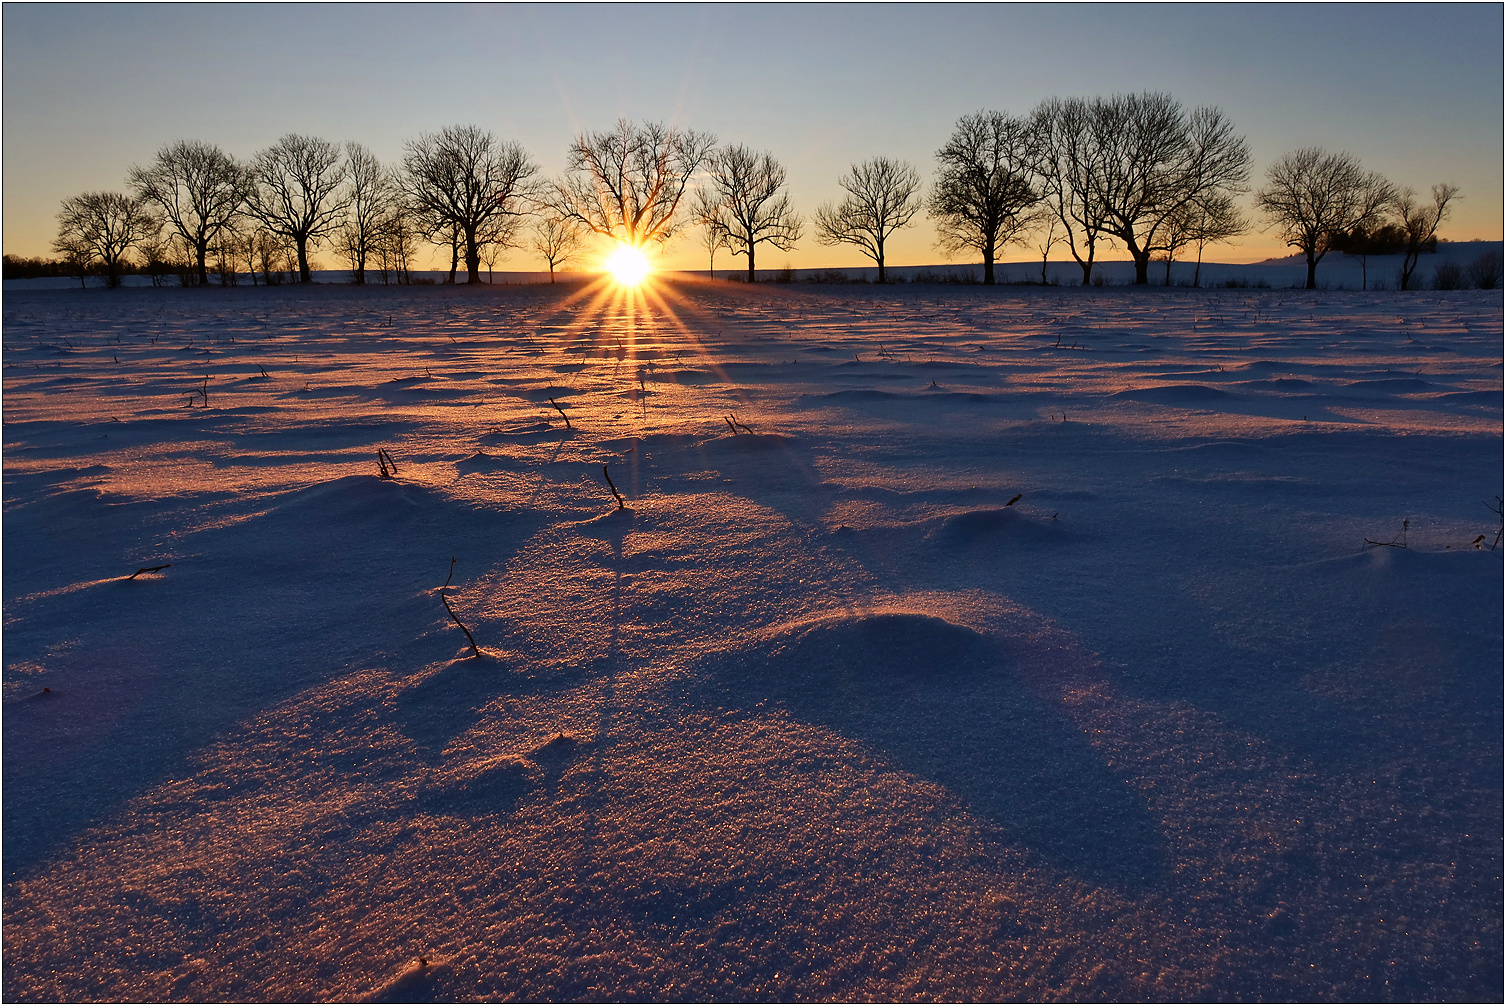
left=245, top=133, right=349, bottom=283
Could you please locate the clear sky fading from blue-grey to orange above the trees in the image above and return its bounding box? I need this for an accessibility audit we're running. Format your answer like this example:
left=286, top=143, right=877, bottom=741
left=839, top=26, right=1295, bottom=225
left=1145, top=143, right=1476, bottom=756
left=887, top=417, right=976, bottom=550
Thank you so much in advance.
left=0, top=3, right=1503, bottom=268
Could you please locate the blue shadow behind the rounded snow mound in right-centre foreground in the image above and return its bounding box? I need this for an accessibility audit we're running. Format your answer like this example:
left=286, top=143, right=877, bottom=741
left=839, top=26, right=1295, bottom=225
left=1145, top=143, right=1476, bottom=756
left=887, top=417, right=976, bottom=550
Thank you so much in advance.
left=690, top=611, right=1164, bottom=889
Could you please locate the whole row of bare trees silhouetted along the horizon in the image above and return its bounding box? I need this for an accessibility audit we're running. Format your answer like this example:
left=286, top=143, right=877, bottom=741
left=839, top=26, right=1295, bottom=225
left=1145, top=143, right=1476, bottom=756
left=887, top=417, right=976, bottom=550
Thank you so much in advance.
left=44, top=92, right=1459, bottom=289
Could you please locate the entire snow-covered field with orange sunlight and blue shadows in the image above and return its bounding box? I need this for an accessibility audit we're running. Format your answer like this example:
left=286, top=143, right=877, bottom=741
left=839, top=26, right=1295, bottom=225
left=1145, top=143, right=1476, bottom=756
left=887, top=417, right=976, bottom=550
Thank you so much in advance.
left=3, top=282, right=1506, bottom=1001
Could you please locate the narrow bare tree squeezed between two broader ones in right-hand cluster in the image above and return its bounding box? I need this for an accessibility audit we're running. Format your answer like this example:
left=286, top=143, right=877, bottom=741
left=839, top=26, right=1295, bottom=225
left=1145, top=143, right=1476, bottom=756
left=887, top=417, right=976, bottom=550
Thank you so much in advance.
left=1030, top=98, right=1108, bottom=286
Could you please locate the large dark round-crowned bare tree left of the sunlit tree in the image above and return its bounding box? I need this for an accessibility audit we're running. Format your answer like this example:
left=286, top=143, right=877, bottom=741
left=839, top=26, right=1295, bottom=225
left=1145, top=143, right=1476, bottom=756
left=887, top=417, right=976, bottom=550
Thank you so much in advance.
left=402, top=125, right=538, bottom=283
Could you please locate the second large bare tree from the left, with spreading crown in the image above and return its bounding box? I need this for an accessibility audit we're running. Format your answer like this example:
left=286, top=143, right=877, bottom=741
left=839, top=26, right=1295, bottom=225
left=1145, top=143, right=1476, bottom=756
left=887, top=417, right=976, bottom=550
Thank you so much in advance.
left=128, top=140, right=245, bottom=285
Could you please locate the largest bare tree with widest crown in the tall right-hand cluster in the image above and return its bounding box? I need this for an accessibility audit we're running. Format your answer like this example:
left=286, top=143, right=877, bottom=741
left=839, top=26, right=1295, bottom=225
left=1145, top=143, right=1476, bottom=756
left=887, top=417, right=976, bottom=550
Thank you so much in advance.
left=1092, top=92, right=1250, bottom=285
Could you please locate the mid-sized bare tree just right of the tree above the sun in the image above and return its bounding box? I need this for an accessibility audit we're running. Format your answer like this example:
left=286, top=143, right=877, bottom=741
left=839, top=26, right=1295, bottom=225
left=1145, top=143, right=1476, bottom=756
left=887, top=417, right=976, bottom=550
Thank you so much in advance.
left=696, top=146, right=804, bottom=283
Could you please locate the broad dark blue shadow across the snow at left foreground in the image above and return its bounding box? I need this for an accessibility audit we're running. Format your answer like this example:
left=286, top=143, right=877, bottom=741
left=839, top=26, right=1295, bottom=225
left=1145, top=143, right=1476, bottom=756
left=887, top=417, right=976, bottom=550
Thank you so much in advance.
left=3, top=476, right=541, bottom=878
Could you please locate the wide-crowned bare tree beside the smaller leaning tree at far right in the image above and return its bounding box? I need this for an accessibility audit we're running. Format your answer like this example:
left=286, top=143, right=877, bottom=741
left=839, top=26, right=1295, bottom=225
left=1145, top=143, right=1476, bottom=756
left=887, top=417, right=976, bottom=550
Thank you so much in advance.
left=1254, top=146, right=1395, bottom=289
